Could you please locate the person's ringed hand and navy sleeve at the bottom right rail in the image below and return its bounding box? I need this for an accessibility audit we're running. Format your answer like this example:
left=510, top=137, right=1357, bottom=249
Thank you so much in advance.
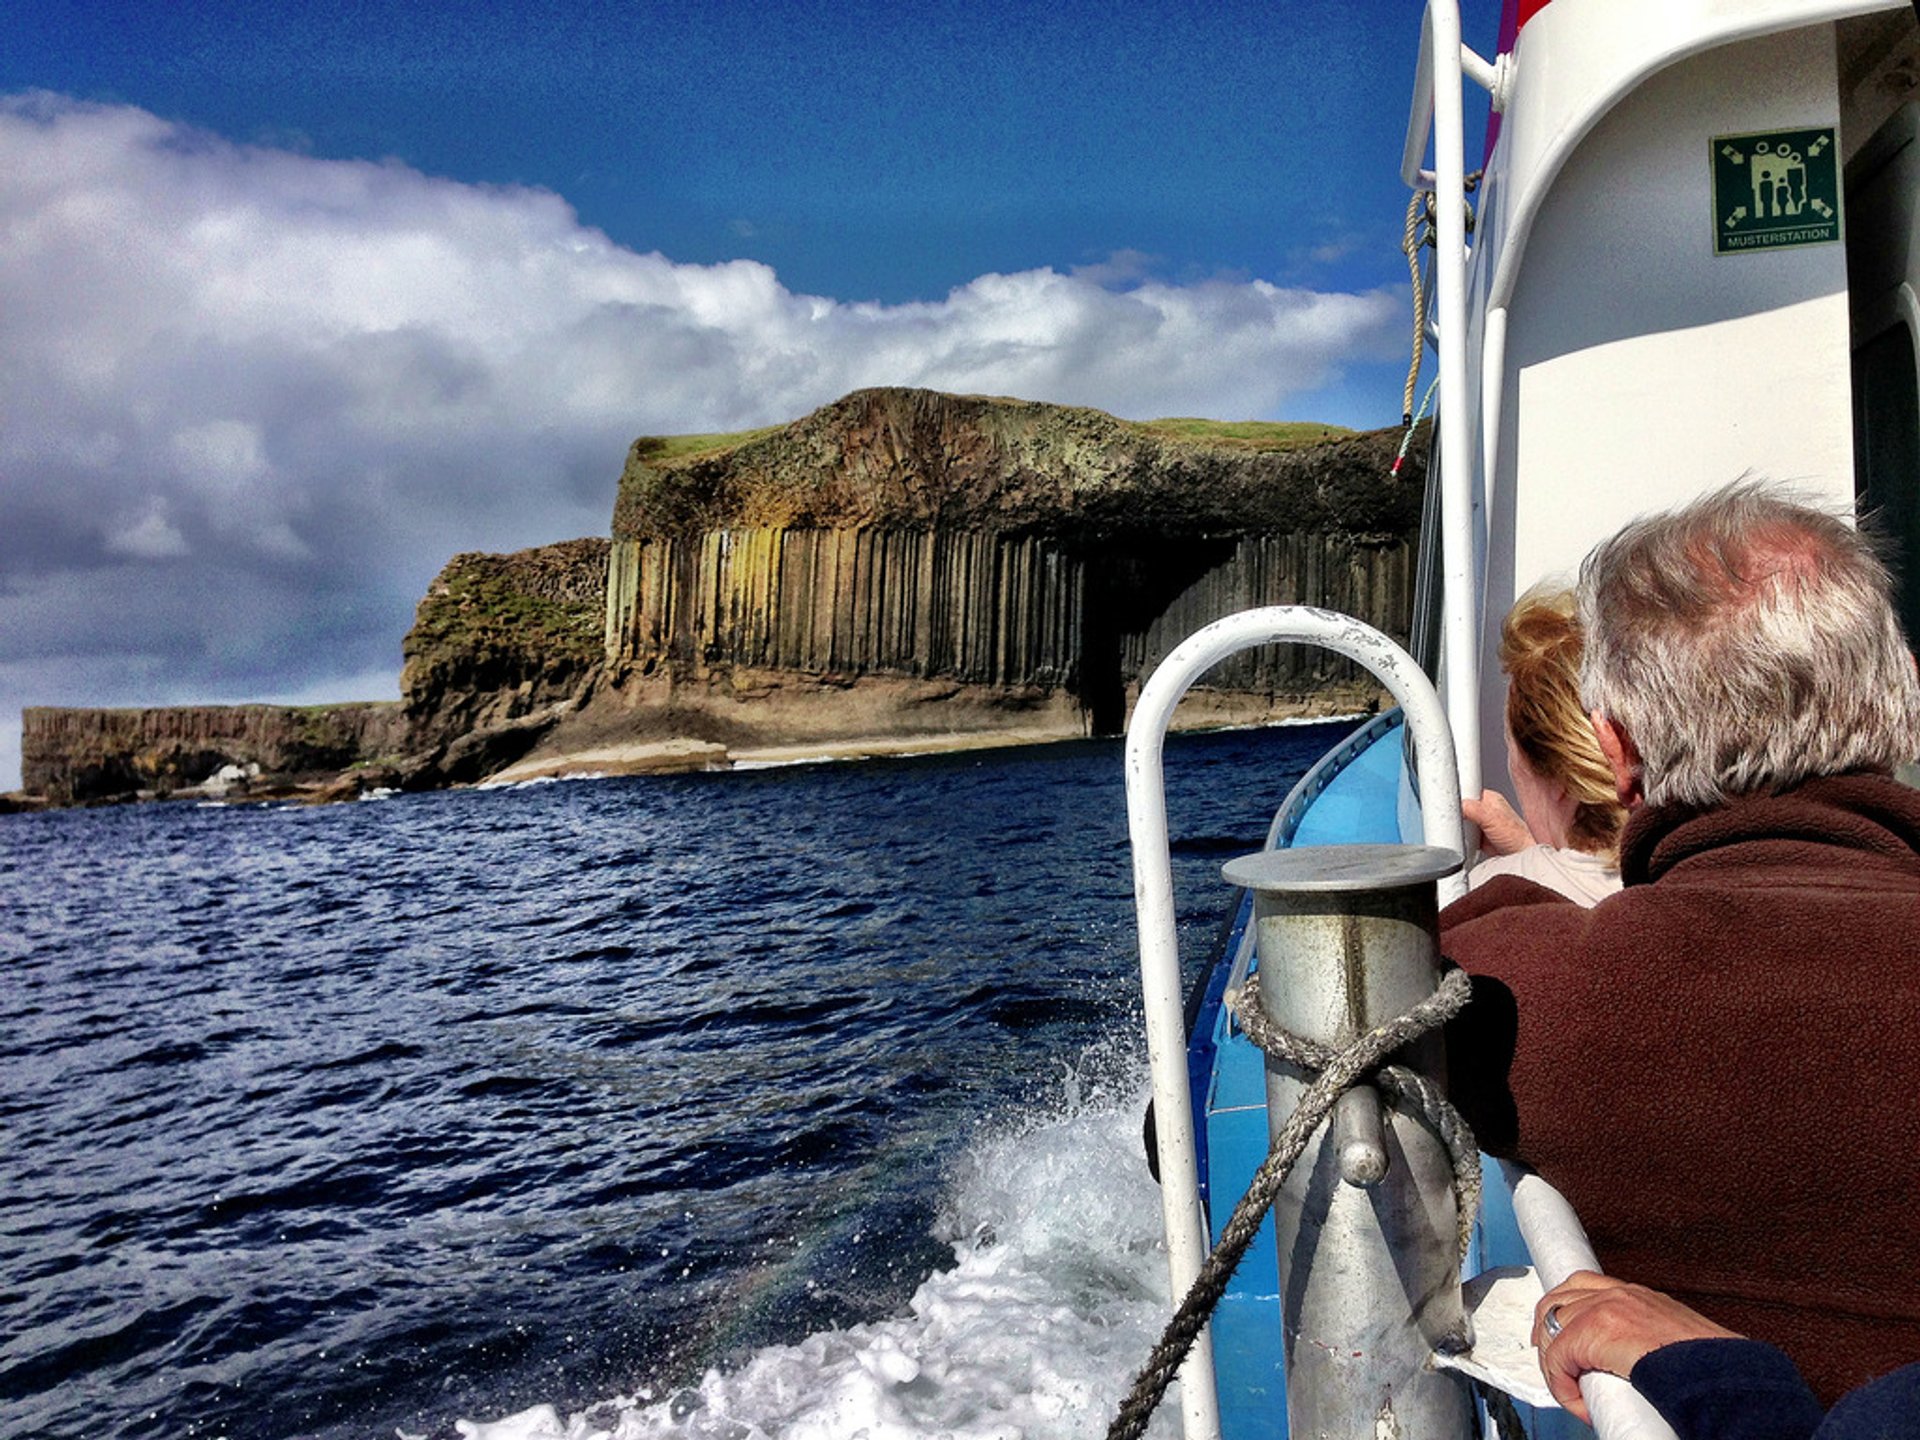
left=1534, top=1271, right=1920, bottom=1440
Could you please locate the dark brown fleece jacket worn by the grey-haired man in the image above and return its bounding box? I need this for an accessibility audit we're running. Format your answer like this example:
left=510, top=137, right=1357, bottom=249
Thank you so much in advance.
left=1440, top=774, right=1920, bottom=1404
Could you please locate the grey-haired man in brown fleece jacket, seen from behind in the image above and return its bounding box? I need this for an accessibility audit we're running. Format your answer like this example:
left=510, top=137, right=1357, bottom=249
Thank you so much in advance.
left=1442, top=484, right=1920, bottom=1402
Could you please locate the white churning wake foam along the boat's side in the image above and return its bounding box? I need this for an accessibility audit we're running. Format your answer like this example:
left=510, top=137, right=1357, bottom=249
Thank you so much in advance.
left=459, top=1077, right=1179, bottom=1440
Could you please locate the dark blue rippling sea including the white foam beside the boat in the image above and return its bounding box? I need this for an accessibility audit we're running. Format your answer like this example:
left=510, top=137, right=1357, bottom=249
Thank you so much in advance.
left=0, top=726, right=1340, bottom=1440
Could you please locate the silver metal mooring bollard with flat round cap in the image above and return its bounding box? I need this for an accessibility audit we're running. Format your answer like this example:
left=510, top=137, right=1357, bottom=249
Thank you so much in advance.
left=1225, top=845, right=1473, bottom=1440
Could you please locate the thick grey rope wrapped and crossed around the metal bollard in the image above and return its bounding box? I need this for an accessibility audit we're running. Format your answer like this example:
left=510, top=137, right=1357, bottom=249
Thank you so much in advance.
left=1106, top=970, right=1480, bottom=1440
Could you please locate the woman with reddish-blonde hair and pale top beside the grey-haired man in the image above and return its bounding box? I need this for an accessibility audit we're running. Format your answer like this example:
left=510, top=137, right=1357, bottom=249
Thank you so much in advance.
left=1461, top=589, right=1626, bottom=904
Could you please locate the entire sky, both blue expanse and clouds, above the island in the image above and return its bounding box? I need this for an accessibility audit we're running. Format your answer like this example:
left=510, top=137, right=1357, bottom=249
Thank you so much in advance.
left=0, top=0, right=1498, bottom=787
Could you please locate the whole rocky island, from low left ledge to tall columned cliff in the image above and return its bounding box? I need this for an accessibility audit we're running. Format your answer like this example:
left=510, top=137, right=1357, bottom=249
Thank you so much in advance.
left=23, top=388, right=1425, bottom=804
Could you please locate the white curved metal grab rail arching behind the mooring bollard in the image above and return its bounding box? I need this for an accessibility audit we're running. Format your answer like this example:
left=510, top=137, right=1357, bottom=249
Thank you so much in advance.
left=1127, top=605, right=1467, bottom=1440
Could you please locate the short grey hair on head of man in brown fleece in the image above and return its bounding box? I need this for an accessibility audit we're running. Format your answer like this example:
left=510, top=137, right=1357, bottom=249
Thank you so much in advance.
left=1574, top=480, right=1920, bottom=806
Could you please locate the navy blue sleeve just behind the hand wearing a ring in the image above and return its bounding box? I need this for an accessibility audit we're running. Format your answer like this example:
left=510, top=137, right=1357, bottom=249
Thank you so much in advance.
left=1628, top=1340, right=1820, bottom=1440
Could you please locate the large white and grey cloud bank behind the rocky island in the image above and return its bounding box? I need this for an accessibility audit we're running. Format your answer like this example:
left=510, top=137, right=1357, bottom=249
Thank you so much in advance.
left=0, top=96, right=1402, bottom=785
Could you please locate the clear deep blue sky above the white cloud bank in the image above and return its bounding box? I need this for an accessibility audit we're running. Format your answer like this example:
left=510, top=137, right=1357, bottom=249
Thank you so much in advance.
left=0, top=0, right=1459, bottom=301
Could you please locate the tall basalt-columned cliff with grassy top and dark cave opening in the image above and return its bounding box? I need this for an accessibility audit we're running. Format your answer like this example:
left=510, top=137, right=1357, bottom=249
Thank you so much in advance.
left=607, top=390, right=1423, bottom=739
